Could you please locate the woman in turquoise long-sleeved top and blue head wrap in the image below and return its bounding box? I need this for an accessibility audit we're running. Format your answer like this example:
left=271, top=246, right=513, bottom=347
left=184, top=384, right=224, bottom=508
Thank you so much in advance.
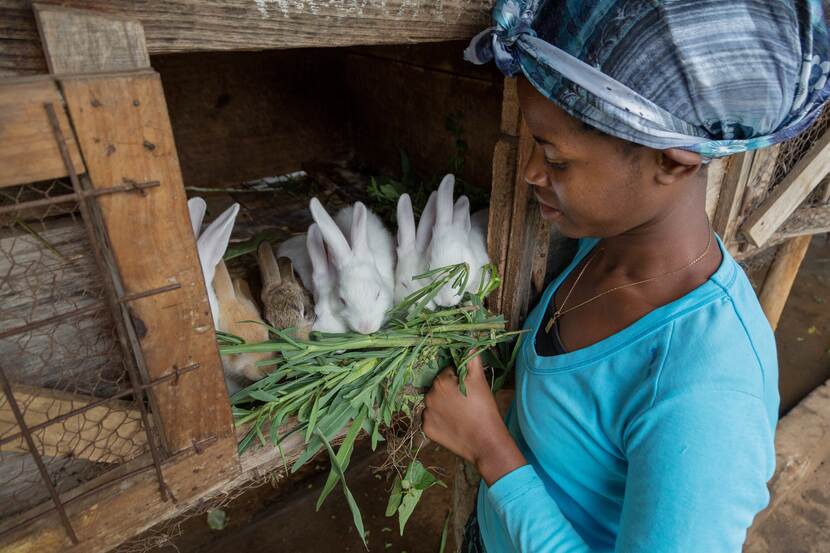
left=424, top=0, right=830, bottom=553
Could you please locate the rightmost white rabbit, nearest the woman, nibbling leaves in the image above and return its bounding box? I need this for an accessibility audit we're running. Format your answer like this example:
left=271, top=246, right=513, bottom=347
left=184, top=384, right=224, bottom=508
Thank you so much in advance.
left=427, top=174, right=489, bottom=307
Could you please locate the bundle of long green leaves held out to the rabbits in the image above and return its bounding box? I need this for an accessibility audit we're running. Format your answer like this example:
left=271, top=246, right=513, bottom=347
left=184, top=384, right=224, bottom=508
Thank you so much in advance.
left=220, top=264, right=518, bottom=544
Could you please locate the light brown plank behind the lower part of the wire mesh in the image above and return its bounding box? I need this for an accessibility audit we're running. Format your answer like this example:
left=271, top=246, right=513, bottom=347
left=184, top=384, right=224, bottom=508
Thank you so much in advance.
left=0, top=384, right=147, bottom=463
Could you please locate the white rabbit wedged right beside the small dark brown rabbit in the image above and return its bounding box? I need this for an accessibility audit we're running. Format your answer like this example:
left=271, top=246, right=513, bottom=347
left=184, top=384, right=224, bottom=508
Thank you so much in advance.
left=306, top=224, right=347, bottom=332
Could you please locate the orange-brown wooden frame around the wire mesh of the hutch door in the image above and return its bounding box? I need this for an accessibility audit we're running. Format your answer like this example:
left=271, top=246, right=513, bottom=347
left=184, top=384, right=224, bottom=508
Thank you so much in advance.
left=0, top=6, right=241, bottom=553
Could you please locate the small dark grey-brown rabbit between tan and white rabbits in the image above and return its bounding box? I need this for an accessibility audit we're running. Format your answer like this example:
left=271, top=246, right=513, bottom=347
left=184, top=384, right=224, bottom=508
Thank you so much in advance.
left=257, top=242, right=314, bottom=339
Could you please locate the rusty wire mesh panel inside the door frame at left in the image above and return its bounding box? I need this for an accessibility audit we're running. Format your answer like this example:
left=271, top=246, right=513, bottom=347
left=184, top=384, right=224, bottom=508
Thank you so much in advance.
left=0, top=180, right=149, bottom=525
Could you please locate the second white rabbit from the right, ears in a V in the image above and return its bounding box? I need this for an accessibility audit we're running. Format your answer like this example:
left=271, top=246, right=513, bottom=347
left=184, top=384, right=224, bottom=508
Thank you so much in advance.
left=395, top=192, right=435, bottom=304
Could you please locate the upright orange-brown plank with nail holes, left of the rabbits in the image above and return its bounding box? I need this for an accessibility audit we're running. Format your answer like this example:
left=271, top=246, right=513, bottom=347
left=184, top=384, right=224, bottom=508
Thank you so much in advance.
left=62, top=71, right=233, bottom=451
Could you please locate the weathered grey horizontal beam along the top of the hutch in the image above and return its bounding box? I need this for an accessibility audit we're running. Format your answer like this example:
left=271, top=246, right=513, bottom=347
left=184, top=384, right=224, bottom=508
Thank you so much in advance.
left=0, top=0, right=492, bottom=75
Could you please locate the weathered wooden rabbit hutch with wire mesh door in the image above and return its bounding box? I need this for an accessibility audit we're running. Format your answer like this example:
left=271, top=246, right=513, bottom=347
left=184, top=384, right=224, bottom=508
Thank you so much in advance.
left=0, top=0, right=830, bottom=553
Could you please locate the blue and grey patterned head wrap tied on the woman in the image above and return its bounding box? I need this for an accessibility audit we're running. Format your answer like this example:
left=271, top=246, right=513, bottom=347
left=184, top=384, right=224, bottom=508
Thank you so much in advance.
left=464, top=0, right=830, bottom=158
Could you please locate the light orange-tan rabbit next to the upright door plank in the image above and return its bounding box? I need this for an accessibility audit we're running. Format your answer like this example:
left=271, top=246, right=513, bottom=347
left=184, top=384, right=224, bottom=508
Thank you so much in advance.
left=213, top=261, right=275, bottom=380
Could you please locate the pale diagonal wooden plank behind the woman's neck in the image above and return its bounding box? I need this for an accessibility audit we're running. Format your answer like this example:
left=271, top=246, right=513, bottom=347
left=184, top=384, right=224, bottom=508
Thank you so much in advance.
left=741, top=131, right=830, bottom=246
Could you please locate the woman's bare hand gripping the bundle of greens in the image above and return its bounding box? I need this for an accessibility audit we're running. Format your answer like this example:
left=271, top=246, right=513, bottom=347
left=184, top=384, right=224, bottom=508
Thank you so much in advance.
left=423, top=357, right=527, bottom=485
